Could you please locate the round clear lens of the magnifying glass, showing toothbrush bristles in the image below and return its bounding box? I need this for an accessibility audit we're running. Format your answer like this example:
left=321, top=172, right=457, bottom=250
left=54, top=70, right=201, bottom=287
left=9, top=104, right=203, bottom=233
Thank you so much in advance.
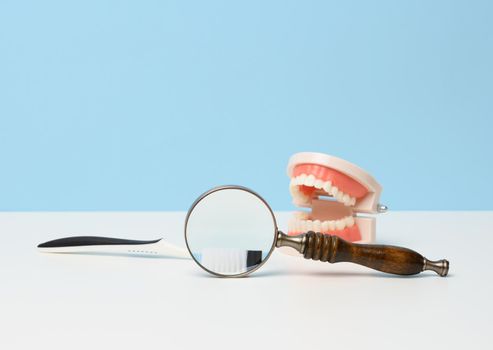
left=185, top=187, right=277, bottom=277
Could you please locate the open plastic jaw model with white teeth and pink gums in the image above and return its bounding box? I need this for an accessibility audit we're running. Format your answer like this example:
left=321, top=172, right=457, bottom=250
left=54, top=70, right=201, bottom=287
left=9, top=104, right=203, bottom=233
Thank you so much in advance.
left=288, top=152, right=386, bottom=243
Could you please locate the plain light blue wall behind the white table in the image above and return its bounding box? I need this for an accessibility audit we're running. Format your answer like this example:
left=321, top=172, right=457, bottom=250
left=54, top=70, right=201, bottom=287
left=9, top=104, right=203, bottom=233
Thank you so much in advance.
left=0, top=0, right=493, bottom=210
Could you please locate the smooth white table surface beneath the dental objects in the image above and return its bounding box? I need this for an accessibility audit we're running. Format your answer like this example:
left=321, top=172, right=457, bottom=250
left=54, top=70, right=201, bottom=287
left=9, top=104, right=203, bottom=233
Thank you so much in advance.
left=0, top=212, right=493, bottom=350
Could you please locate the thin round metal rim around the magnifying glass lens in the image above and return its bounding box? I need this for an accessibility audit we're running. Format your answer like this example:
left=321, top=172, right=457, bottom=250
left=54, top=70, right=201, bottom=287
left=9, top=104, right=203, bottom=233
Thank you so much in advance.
left=185, top=185, right=279, bottom=278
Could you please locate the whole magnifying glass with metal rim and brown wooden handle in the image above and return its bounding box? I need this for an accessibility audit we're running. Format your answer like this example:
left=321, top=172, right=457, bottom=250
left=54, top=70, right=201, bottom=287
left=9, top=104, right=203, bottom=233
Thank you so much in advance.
left=185, top=186, right=449, bottom=277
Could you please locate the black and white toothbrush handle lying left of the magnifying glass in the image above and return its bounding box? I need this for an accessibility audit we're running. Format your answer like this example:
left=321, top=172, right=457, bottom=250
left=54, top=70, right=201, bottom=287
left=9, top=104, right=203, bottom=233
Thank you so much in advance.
left=38, top=236, right=190, bottom=259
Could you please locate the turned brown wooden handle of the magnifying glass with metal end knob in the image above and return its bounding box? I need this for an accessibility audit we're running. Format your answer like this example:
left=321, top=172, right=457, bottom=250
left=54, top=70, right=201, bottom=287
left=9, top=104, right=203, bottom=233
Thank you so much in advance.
left=303, top=232, right=449, bottom=276
